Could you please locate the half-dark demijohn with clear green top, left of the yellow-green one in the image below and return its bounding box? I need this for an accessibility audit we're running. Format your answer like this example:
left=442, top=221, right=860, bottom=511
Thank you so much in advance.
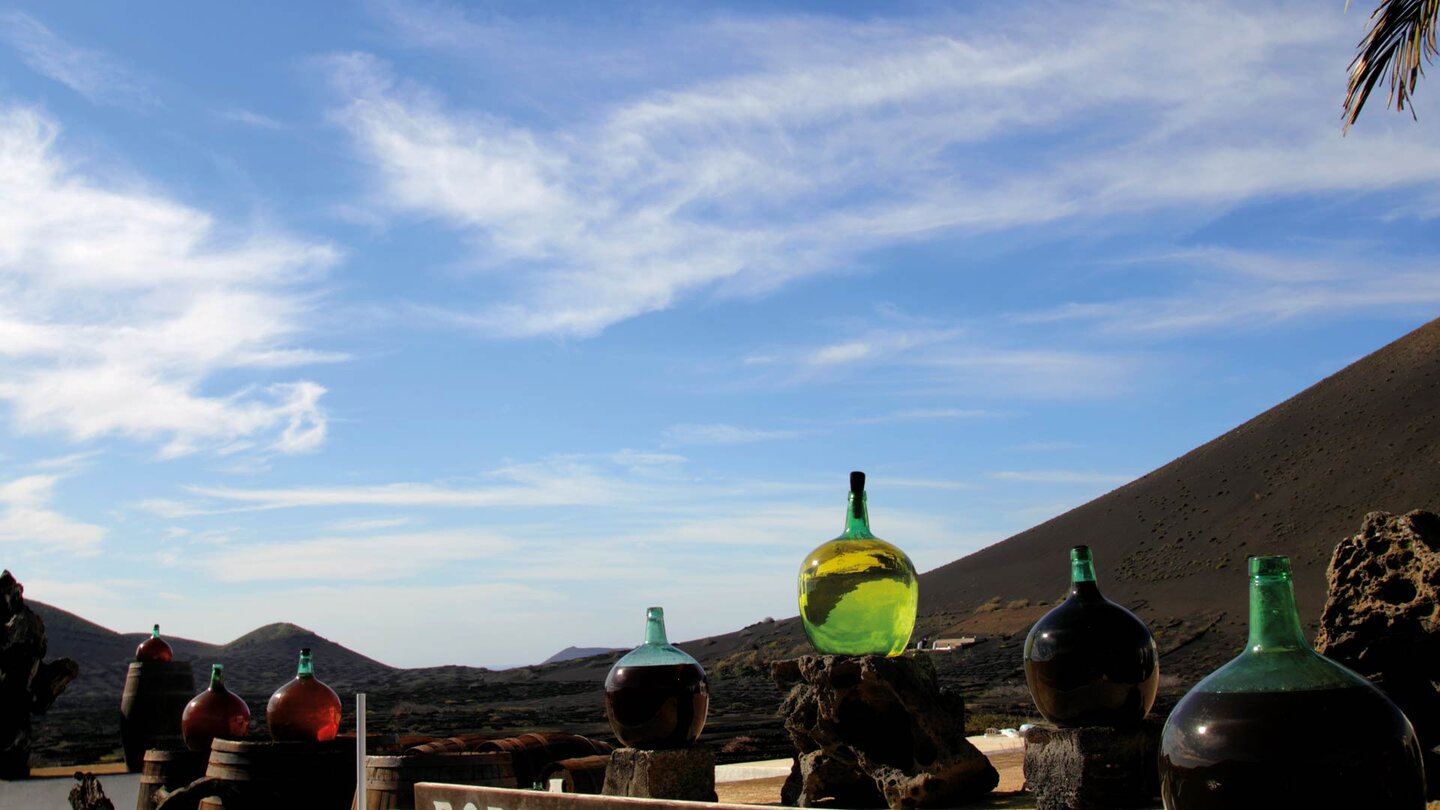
left=605, top=607, right=710, bottom=751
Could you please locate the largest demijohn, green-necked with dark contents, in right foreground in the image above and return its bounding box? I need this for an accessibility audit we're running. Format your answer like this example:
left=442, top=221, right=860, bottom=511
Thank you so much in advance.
left=1159, top=556, right=1426, bottom=810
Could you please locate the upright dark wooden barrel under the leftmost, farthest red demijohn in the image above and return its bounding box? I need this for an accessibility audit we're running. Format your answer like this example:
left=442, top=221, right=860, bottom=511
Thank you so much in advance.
left=120, top=662, right=196, bottom=774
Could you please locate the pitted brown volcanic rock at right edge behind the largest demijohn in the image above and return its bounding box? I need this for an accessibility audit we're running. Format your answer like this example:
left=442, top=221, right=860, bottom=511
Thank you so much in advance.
left=1315, top=512, right=1440, bottom=798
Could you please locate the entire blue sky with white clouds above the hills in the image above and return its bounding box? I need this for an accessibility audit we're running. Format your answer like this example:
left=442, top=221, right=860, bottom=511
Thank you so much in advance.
left=0, top=0, right=1440, bottom=666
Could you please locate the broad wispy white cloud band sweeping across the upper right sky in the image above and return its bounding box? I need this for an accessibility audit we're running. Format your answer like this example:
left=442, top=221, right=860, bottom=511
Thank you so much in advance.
left=331, top=1, right=1440, bottom=337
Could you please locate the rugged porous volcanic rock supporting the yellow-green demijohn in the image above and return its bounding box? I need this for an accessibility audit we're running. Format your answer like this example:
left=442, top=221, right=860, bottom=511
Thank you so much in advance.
left=770, top=653, right=999, bottom=809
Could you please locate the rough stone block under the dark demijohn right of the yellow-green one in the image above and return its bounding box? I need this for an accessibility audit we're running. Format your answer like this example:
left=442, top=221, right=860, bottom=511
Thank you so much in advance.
left=1025, top=719, right=1164, bottom=810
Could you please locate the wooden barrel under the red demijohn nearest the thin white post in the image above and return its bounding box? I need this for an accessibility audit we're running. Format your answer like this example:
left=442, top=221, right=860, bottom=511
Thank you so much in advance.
left=204, top=738, right=356, bottom=810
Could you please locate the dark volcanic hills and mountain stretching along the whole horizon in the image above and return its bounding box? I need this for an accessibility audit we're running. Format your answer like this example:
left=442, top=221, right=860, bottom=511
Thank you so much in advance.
left=19, top=320, right=1440, bottom=761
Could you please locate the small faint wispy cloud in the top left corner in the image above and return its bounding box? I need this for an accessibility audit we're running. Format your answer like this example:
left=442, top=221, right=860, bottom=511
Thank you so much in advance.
left=0, top=10, right=160, bottom=107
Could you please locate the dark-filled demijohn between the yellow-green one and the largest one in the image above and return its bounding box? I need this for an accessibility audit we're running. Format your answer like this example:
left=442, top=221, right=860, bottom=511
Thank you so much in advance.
left=1025, top=546, right=1161, bottom=728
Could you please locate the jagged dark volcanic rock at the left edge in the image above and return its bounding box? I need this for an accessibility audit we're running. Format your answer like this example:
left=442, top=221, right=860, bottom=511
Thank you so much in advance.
left=0, top=571, right=81, bottom=780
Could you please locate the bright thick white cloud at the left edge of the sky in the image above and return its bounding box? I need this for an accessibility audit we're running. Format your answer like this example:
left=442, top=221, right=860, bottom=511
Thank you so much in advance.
left=0, top=108, right=340, bottom=457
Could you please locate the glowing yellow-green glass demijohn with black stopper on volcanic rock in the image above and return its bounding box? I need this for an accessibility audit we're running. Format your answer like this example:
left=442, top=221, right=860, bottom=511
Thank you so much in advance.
left=799, top=471, right=920, bottom=656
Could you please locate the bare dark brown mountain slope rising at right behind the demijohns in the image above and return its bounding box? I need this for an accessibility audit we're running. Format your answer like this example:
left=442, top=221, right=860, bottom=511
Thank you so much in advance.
left=920, top=312, right=1440, bottom=679
